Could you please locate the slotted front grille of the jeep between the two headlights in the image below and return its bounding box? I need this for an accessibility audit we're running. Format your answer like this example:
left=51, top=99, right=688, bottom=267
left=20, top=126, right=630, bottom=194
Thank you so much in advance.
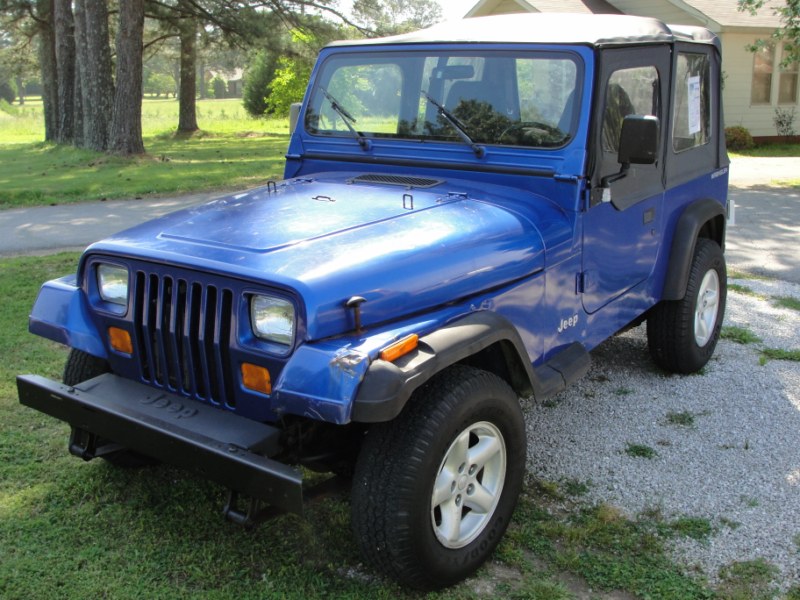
left=134, top=271, right=234, bottom=406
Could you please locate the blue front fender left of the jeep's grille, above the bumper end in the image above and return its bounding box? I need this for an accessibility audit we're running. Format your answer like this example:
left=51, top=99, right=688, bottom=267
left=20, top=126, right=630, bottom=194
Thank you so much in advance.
left=28, top=275, right=108, bottom=358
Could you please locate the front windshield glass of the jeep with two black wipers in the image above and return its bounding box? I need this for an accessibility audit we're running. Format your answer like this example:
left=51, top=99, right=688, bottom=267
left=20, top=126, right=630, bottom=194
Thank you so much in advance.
left=305, top=49, right=578, bottom=148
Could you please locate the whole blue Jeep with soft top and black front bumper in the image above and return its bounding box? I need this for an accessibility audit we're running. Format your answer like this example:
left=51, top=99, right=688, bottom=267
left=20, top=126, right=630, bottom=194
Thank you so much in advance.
left=18, top=14, right=728, bottom=589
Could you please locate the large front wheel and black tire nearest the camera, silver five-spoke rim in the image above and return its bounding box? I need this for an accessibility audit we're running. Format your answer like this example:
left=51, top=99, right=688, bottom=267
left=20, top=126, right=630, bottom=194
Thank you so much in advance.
left=352, top=365, right=526, bottom=590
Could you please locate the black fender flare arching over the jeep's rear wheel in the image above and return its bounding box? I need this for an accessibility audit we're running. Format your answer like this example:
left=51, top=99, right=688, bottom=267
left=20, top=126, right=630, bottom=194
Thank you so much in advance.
left=661, top=198, right=726, bottom=300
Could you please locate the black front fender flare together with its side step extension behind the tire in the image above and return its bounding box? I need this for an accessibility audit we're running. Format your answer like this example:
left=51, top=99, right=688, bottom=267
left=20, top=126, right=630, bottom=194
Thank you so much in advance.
left=350, top=311, right=589, bottom=423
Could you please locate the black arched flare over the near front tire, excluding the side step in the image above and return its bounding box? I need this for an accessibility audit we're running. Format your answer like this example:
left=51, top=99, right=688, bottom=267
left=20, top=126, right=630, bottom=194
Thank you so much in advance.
left=351, top=311, right=541, bottom=423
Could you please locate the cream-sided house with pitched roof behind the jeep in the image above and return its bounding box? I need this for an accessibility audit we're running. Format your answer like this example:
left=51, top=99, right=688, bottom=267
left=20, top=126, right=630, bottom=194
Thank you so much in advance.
left=465, top=0, right=800, bottom=137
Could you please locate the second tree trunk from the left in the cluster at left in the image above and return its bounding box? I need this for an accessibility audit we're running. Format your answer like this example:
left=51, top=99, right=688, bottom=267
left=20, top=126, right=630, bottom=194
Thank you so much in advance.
left=53, top=0, right=75, bottom=144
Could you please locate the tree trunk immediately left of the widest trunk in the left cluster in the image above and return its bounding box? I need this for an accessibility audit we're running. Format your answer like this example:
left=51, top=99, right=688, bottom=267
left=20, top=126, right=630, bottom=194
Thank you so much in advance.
left=75, top=0, right=114, bottom=152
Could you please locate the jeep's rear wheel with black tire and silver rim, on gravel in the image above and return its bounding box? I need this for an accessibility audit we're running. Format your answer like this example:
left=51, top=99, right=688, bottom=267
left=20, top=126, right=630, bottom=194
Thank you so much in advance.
left=647, top=238, right=727, bottom=374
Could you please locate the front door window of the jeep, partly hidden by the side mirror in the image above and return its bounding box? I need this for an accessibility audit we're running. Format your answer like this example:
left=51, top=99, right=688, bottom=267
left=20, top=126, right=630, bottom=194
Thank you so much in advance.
left=603, top=66, right=660, bottom=153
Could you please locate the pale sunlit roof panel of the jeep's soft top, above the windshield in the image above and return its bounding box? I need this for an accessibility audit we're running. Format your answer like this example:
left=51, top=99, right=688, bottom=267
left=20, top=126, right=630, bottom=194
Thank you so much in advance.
left=331, top=13, right=719, bottom=48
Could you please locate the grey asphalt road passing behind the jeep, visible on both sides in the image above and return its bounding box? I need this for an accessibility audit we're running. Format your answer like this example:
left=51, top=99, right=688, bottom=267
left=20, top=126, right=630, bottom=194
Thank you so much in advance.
left=0, top=158, right=800, bottom=283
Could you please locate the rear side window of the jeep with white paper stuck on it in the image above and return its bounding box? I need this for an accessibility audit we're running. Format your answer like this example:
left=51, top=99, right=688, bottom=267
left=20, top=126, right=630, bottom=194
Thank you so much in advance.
left=672, top=52, right=711, bottom=152
